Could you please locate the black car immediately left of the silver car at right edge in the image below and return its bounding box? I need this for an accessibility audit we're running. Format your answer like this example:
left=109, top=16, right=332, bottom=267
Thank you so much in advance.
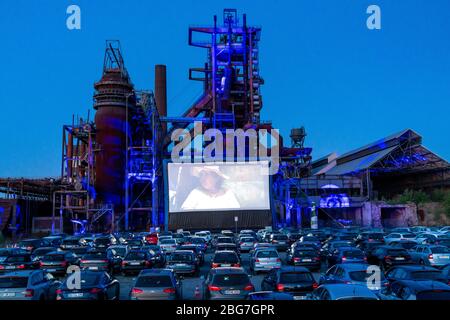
left=367, top=246, right=412, bottom=270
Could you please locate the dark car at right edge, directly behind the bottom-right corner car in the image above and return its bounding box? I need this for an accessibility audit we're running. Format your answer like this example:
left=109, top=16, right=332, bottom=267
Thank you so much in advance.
left=386, top=265, right=448, bottom=283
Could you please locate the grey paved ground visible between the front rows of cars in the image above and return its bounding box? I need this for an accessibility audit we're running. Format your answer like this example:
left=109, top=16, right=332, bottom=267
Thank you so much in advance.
left=116, top=252, right=320, bottom=300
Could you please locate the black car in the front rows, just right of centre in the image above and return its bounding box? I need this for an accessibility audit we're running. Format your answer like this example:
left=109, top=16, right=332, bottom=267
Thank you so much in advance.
left=261, top=267, right=318, bottom=299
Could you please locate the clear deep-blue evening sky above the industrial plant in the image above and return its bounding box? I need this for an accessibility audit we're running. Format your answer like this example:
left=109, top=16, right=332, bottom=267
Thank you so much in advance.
left=0, top=0, right=450, bottom=177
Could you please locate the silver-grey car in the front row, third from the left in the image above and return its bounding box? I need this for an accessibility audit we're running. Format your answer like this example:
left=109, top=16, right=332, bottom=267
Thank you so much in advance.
left=130, top=269, right=183, bottom=300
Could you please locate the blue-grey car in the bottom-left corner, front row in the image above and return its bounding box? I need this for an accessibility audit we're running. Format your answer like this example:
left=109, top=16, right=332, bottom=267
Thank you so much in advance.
left=0, top=270, right=61, bottom=301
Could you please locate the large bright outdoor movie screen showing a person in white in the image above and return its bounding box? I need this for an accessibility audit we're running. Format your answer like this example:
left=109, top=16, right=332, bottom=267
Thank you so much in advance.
left=167, top=161, right=270, bottom=213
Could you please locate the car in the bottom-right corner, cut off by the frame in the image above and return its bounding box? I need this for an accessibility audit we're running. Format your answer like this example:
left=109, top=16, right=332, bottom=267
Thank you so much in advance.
left=379, top=280, right=450, bottom=301
